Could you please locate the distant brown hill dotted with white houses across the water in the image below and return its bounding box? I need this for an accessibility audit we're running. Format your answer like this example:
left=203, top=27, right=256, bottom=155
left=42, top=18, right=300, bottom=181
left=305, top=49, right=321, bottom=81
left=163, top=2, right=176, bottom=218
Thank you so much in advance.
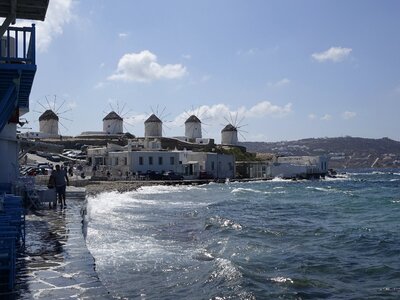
left=240, top=137, right=400, bottom=168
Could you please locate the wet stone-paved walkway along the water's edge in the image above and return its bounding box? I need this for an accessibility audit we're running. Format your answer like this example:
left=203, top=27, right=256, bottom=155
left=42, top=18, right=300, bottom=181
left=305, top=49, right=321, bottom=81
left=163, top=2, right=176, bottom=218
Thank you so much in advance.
left=0, top=188, right=112, bottom=299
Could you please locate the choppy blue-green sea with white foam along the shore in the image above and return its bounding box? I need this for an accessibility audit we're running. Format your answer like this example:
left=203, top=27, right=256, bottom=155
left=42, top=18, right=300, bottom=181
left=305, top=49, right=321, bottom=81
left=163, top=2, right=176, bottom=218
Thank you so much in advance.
left=86, top=170, right=400, bottom=299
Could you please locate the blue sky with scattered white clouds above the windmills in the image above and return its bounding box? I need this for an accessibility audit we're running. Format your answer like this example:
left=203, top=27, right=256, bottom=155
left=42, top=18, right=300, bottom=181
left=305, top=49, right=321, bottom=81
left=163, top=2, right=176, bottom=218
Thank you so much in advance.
left=3, top=0, right=400, bottom=142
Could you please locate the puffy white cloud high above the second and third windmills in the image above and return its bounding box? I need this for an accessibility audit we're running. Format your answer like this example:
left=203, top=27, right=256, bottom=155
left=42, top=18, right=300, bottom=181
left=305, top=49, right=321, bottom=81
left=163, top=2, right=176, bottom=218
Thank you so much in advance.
left=108, top=50, right=187, bottom=82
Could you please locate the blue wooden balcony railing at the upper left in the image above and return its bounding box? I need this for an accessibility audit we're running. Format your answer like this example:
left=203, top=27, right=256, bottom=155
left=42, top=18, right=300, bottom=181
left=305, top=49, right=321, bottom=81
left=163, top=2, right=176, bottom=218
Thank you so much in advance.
left=0, top=24, right=36, bottom=64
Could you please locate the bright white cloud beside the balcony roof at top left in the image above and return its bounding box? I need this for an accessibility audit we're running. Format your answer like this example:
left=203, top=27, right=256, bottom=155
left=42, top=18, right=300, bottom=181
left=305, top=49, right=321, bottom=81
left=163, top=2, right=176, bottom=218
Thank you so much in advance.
left=17, top=0, right=73, bottom=52
